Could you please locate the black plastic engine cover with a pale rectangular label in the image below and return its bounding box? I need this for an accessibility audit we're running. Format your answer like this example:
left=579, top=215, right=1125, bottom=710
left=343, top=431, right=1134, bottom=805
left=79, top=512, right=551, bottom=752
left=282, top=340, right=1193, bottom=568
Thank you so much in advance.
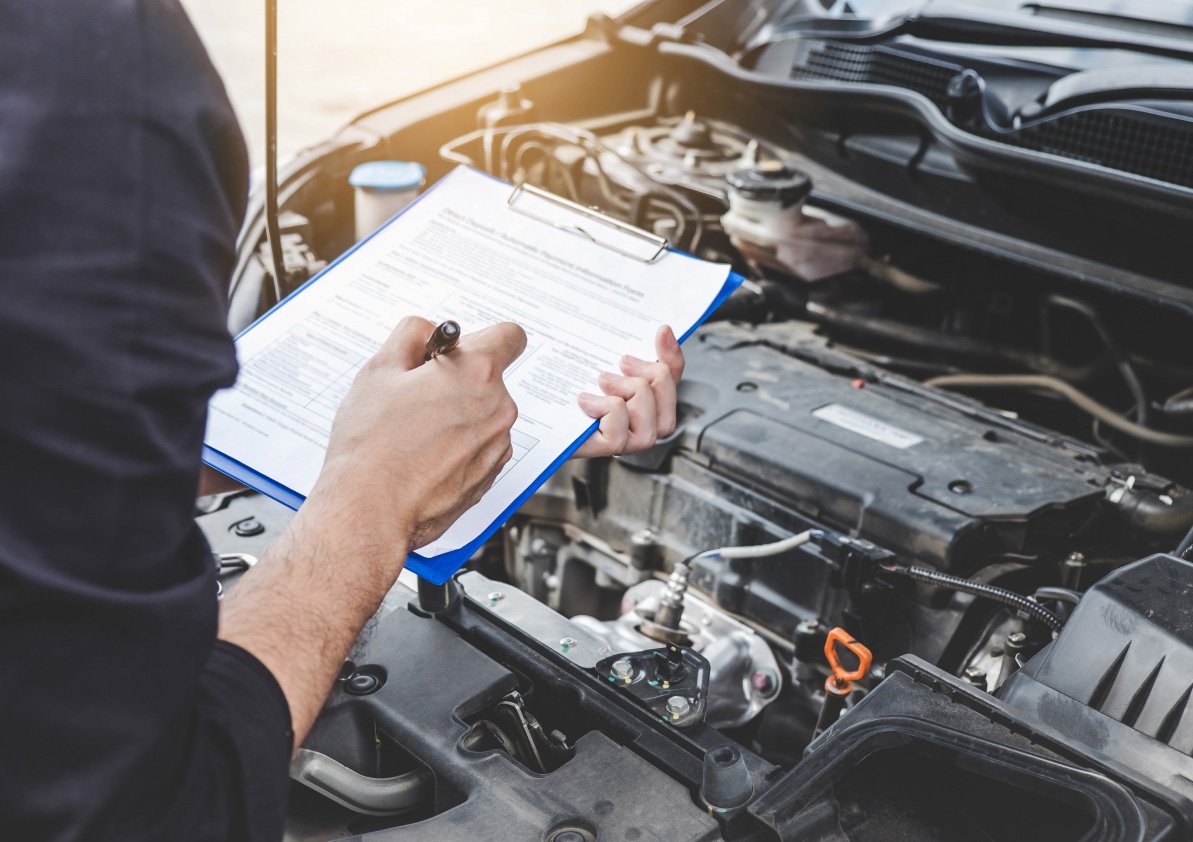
left=681, top=324, right=1109, bottom=572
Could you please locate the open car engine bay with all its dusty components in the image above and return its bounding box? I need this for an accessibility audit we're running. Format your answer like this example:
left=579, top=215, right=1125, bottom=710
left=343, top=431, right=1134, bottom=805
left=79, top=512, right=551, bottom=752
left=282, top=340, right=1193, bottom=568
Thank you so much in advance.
left=209, top=4, right=1193, bottom=842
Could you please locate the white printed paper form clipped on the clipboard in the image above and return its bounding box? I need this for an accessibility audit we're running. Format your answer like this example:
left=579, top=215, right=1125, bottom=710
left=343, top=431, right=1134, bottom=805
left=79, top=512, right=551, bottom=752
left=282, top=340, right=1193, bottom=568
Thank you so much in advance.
left=206, top=168, right=729, bottom=558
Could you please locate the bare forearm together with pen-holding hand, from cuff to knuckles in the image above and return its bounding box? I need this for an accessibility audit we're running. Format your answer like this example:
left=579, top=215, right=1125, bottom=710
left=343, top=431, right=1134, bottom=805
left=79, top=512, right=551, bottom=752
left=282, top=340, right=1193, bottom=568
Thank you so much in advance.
left=220, top=318, right=526, bottom=744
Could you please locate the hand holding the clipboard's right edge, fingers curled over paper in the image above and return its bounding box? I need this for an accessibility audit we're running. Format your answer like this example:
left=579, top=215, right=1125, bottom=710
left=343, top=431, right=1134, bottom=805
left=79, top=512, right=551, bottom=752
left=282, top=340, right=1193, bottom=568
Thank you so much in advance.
left=576, top=327, right=684, bottom=457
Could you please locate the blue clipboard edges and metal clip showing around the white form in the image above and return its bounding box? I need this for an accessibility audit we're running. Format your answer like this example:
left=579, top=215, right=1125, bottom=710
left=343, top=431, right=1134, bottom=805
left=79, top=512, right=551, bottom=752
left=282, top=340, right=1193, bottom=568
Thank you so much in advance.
left=203, top=171, right=744, bottom=584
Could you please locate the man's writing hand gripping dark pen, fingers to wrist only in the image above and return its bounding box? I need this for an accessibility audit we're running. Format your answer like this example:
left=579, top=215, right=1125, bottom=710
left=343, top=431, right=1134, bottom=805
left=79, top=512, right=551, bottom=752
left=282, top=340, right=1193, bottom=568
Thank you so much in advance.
left=311, top=318, right=526, bottom=553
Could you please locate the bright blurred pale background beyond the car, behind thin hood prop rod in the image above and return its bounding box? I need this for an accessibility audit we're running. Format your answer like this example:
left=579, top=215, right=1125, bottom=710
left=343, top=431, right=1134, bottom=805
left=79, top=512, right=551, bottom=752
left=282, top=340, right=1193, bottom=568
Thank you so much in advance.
left=181, top=0, right=637, bottom=166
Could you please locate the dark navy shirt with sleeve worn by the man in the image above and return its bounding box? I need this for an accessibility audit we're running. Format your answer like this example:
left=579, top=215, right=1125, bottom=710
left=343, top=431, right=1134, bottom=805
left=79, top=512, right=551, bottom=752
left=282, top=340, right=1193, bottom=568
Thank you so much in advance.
left=0, top=0, right=291, bottom=842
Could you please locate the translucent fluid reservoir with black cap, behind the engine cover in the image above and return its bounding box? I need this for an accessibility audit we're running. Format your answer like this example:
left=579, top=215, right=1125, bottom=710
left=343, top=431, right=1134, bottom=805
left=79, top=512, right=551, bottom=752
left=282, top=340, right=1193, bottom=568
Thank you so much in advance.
left=721, top=161, right=869, bottom=281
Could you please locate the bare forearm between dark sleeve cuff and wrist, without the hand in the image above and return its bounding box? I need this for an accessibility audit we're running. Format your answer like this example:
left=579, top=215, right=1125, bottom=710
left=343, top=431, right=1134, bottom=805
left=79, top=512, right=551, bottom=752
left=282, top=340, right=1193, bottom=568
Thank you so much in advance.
left=220, top=495, right=409, bottom=745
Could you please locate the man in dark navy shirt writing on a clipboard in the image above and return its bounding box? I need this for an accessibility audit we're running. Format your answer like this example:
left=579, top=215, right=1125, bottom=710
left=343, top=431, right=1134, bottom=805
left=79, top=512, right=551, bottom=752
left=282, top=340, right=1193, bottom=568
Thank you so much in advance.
left=0, top=0, right=682, bottom=842
